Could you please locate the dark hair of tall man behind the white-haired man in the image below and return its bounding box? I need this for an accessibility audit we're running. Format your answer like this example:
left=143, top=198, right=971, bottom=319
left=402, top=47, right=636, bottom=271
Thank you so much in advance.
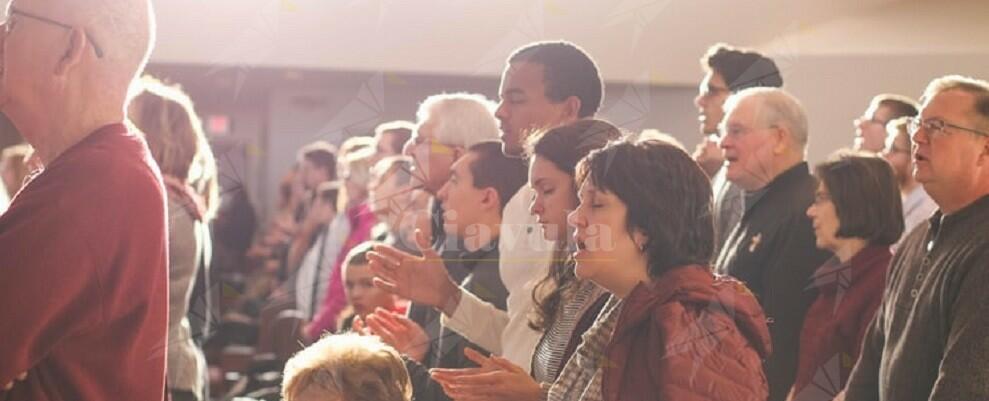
left=701, top=43, right=783, bottom=93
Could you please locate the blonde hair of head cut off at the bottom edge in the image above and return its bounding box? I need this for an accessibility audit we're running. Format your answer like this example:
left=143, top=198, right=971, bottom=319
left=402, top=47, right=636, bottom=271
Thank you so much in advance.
left=282, top=333, right=412, bottom=401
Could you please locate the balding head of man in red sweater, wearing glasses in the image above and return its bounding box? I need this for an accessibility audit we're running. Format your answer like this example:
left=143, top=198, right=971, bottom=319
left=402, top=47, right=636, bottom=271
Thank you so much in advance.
left=0, top=0, right=154, bottom=160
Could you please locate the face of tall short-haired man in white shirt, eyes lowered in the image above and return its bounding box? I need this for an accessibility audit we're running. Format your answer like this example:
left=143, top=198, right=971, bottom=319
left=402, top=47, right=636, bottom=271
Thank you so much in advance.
left=495, top=62, right=566, bottom=156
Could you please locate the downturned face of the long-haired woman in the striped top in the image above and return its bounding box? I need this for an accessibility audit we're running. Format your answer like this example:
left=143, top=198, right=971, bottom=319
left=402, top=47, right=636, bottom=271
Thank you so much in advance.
left=529, top=155, right=577, bottom=241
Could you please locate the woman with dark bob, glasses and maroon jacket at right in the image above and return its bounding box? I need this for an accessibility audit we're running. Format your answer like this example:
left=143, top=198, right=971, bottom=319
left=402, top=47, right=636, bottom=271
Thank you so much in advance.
left=787, top=152, right=904, bottom=401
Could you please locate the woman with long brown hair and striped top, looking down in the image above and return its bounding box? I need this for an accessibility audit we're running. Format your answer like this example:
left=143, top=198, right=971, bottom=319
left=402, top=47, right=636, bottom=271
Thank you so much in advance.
left=434, top=120, right=622, bottom=401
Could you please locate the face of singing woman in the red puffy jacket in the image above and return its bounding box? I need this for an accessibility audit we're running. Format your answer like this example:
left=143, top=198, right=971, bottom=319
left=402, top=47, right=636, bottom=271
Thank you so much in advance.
left=568, top=179, right=641, bottom=289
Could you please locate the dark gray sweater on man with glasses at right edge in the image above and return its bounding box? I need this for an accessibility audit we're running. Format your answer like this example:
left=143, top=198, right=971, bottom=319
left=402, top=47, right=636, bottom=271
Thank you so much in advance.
left=845, top=196, right=989, bottom=401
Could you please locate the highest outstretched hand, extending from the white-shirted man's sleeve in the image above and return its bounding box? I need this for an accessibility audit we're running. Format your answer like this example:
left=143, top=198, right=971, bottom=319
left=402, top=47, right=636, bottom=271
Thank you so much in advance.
left=368, top=230, right=460, bottom=311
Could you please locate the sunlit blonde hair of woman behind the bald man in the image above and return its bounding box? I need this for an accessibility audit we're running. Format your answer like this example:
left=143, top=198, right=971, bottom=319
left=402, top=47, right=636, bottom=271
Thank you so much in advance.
left=127, top=76, right=219, bottom=219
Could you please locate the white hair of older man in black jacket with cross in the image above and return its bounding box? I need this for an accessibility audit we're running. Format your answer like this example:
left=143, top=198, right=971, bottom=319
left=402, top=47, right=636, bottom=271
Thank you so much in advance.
left=722, top=87, right=809, bottom=152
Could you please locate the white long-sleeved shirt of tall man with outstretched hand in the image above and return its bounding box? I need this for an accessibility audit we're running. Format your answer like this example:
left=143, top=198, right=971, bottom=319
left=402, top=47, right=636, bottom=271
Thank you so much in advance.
left=442, top=186, right=554, bottom=372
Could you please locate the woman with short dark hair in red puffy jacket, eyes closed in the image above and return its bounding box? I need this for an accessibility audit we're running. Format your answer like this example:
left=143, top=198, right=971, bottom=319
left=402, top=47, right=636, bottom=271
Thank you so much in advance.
left=548, top=140, right=770, bottom=401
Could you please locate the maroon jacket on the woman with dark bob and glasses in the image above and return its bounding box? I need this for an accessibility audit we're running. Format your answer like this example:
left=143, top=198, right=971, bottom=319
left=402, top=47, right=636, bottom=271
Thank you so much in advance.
left=787, top=246, right=893, bottom=401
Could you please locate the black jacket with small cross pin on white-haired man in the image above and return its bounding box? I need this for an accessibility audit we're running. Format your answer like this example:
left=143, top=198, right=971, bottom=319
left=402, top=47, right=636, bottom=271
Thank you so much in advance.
left=716, top=163, right=831, bottom=401
